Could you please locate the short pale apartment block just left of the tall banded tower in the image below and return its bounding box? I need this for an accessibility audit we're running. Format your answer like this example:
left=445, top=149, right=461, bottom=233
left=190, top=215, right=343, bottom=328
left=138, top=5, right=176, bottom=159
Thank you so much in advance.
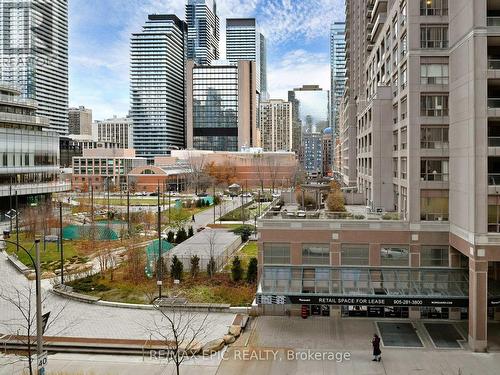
left=95, top=116, right=134, bottom=148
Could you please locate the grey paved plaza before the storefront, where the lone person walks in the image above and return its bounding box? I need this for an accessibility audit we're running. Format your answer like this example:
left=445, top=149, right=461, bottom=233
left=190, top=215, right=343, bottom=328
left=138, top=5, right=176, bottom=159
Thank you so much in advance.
left=217, top=317, right=500, bottom=375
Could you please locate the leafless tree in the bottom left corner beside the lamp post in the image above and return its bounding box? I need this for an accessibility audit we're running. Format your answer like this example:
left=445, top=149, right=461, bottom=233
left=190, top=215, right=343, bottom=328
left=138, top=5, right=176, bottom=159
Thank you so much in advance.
left=0, top=284, right=76, bottom=375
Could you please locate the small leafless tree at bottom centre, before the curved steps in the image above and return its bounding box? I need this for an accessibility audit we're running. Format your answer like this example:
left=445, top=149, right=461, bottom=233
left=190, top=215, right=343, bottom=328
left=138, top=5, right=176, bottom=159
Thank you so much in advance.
left=148, top=299, right=210, bottom=375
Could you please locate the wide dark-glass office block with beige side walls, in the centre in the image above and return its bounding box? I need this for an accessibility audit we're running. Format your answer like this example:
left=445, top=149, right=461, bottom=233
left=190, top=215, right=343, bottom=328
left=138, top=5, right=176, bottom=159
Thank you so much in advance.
left=187, top=60, right=260, bottom=151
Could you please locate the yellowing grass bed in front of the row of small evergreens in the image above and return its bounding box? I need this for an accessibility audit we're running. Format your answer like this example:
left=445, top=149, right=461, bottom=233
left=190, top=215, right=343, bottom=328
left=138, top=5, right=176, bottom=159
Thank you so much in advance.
left=69, top=267, right=255, bottom=306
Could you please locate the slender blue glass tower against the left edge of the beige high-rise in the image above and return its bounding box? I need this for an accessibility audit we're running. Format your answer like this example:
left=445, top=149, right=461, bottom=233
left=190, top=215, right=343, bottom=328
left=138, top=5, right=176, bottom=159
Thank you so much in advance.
left=330, top=22, right=346, bottom=134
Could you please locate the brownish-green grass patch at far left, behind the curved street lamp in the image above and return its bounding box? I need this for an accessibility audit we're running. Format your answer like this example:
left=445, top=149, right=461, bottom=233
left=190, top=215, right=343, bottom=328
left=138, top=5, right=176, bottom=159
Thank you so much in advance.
left=7, top=233, right=83, bottom=270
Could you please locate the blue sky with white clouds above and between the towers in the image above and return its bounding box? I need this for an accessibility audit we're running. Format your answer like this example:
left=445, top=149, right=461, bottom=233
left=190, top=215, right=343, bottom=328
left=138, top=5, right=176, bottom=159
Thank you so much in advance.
left=69, top=0, right=344, bottom=120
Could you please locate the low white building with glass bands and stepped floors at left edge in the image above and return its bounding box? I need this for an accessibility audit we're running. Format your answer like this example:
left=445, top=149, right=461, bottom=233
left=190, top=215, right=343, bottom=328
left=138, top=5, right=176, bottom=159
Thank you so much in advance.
left=0, top=83, right=71, bottom=207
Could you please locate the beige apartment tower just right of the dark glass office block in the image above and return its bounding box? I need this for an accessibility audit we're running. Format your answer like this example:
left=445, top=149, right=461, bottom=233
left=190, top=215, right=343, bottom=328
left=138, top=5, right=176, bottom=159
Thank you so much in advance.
left=259, top=99, right=293, bottom=152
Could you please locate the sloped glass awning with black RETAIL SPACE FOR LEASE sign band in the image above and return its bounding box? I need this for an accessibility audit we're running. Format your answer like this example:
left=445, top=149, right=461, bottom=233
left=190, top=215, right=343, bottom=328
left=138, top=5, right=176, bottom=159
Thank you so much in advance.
left=257, top=266, right=500, bottom=307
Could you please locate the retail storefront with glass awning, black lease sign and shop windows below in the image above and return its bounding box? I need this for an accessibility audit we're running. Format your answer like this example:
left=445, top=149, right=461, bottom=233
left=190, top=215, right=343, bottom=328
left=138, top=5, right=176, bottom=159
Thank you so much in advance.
left=257, top=266, right=500, bottom=319
